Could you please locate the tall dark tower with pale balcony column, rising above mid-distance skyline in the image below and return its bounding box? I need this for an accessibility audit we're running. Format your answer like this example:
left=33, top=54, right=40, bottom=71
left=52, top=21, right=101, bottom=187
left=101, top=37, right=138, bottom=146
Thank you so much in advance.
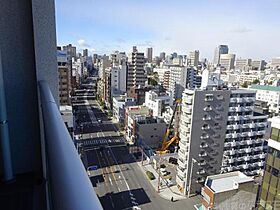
left=126, top=47, right=148, bottom=90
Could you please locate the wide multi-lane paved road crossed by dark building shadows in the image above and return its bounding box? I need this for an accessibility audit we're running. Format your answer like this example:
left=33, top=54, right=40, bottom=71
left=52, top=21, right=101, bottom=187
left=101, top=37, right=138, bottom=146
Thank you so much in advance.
left=72, top=94, right=199, bottom=210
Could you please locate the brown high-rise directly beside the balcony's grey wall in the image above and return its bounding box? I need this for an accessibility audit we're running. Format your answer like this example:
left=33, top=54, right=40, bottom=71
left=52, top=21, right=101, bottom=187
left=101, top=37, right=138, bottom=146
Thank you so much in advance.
left=57, top=50, right=71, bottom=105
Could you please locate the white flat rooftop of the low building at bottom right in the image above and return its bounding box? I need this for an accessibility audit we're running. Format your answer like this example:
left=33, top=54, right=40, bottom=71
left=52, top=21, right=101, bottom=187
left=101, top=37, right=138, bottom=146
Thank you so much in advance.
left=205, top=171, right=254, bottom=193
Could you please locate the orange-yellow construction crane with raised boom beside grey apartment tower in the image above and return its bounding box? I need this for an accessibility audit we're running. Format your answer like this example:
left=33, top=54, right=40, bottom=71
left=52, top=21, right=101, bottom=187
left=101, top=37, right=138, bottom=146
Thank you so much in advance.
left=158, top=99, right=182, bottom=154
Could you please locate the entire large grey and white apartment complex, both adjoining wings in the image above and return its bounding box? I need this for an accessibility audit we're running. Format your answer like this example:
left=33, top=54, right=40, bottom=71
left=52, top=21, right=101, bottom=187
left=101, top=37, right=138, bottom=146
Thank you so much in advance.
left=176, top=75, right=267, bottom=193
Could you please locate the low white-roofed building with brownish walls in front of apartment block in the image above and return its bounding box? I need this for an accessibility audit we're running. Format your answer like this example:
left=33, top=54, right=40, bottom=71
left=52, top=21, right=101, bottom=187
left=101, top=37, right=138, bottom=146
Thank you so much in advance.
left=200, top=171, right=258, bottom=210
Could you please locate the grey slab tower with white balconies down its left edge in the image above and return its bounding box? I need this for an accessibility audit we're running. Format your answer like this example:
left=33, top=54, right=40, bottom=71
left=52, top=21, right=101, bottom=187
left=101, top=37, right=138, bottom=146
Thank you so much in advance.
left=176, top=89, right=230, bottom=194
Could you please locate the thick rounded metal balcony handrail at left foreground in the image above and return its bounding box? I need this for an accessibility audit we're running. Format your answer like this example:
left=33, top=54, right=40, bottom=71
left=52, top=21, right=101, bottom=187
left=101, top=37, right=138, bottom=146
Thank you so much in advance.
left=39, top=81, right=103, bottom=210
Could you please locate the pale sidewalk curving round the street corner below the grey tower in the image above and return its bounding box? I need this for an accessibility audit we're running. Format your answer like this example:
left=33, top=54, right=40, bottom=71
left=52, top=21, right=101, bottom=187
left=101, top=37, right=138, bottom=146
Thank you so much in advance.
left=137, top=162, right=187, bottom=201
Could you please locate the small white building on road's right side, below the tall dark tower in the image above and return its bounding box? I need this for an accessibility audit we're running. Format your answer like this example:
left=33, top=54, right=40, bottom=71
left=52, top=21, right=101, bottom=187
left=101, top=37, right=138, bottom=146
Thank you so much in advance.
left=113, top=95, right=136, bottom=122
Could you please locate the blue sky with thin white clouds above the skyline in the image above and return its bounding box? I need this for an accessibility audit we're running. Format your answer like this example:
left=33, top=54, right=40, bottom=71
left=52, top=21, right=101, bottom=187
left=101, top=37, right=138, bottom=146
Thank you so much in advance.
left=56, top=0, right=280, bottom=60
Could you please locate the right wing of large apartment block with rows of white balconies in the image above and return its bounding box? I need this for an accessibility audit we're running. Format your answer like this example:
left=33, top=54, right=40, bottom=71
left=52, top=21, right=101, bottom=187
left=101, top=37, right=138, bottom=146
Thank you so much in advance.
left=221, top=89, right=268, bottom=176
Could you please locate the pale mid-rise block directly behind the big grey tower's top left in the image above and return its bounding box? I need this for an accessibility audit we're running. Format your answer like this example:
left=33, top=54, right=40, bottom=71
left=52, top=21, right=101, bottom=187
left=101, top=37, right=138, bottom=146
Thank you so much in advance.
left=168, top=66, right=197, bottom=99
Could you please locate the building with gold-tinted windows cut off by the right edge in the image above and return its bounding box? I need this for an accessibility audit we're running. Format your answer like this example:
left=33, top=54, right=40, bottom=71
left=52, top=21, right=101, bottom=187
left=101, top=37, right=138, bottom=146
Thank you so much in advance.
left=258, top=117, right=280, bottom=210
